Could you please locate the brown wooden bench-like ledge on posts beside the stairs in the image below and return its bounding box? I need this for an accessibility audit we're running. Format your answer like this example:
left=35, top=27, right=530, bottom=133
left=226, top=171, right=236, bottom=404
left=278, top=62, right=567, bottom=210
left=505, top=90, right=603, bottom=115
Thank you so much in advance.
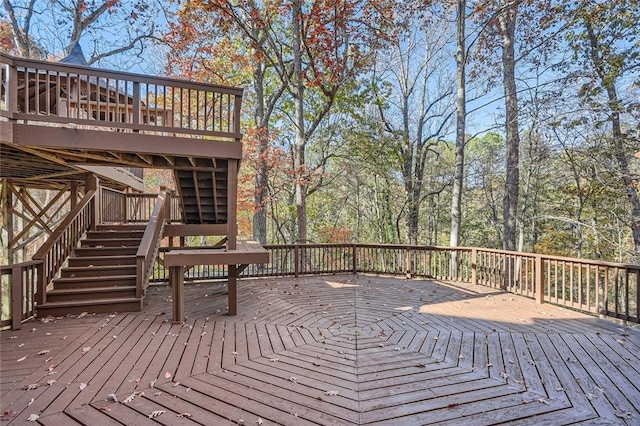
left=164, top=241, right=269, bottom=323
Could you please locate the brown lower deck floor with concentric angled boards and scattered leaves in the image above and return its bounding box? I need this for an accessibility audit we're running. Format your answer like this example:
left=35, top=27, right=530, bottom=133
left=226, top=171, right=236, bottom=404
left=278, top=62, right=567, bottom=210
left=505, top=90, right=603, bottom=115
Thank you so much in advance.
left=0, top=275, right=640, bottom=426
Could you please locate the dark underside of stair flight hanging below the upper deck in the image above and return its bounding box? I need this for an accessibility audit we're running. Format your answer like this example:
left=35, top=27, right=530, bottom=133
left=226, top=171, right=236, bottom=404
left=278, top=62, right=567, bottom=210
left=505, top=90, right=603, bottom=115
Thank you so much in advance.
left=175, top=159, right=228, bottom=224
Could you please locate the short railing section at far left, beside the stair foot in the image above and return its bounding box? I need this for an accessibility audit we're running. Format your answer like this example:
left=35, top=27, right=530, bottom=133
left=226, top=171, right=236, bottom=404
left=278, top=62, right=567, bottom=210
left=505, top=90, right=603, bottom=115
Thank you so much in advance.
left=0, top=261, right=42, bottom=330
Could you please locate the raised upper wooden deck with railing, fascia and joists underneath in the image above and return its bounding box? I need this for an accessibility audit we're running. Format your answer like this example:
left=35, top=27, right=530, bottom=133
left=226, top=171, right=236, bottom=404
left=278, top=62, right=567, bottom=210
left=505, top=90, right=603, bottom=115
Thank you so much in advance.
left=0, top=54, right=242, bottom=186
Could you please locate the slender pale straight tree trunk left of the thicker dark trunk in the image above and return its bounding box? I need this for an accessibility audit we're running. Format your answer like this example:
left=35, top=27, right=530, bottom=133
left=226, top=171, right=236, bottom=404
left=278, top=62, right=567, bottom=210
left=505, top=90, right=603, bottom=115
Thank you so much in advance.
left=449, top=0, right=467, bottom=247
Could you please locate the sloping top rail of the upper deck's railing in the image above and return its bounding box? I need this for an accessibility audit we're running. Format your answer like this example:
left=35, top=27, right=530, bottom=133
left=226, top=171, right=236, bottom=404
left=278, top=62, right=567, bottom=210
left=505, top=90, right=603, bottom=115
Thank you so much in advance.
left=0, top=53, right=244, bottom=96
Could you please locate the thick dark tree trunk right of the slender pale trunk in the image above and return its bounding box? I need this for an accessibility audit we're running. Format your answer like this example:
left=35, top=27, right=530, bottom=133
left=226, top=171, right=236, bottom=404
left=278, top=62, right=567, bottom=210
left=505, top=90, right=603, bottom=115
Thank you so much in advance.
left=499, top=2, right=520, bottom=250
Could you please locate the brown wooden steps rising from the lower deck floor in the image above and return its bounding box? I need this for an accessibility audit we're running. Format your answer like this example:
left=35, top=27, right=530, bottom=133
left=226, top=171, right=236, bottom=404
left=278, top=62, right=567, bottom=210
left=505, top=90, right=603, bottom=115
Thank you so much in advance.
left=37, top=225, right=145, bottom=317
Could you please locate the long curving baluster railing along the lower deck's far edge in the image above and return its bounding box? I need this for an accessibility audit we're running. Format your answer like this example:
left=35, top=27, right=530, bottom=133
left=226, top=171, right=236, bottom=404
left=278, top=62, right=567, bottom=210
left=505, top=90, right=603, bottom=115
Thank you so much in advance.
left=154, top=244, right=640, bottom=323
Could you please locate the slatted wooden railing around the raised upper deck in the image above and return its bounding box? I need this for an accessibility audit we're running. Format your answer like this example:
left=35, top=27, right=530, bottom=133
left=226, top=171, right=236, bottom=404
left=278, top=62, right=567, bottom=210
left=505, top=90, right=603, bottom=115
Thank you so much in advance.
left=0, top=53, right=242, bottom=140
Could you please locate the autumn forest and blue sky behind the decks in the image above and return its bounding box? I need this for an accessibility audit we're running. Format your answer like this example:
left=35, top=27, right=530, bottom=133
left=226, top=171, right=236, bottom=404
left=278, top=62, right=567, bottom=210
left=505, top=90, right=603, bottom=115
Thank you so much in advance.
left=0, top=0, right=640, bottom=263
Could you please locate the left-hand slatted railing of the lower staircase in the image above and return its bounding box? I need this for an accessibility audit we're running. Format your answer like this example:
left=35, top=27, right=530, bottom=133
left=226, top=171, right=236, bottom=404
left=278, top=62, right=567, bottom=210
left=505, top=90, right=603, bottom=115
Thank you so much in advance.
left=33, top=190, right=97, bottom=305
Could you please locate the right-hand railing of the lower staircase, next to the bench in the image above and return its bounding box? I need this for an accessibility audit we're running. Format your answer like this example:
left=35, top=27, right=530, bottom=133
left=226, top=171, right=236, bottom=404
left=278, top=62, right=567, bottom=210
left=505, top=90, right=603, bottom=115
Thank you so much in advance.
left=136, top=190, right=167, bottom=297
